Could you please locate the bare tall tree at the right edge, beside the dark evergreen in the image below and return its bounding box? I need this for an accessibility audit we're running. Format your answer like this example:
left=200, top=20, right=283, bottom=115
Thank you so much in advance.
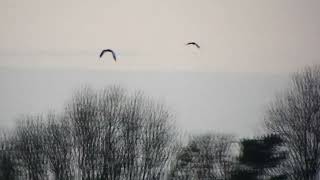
left=265, top=66, right=320, bottom=180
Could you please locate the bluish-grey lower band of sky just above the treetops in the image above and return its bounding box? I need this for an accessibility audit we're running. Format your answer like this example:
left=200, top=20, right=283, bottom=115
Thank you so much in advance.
left=0, top=68, right=289, bottom=136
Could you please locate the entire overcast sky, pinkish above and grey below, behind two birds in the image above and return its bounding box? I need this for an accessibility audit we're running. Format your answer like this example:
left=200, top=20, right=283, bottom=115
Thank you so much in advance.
left=0, top=0, right=320, bottom=135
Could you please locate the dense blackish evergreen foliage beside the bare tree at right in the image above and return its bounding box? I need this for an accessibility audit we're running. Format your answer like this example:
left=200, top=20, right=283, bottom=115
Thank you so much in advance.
left=232, top=134, right=285, bottom=180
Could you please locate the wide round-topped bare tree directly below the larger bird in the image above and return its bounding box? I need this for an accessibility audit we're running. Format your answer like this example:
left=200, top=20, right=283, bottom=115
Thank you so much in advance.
left=67, top=86, right=175, bottom=180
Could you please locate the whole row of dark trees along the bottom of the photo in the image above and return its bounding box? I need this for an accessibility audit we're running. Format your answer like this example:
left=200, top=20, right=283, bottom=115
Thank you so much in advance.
left=0, top=66, right=320, bottom=180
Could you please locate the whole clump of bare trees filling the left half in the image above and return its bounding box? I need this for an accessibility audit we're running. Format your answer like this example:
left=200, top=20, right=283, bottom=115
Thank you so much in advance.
left=0, top=86, right=177, bottom=180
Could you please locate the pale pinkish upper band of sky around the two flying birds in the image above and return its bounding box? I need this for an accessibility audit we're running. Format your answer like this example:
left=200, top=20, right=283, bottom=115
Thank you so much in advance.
left=0, top=0, right=320, bottom=72
